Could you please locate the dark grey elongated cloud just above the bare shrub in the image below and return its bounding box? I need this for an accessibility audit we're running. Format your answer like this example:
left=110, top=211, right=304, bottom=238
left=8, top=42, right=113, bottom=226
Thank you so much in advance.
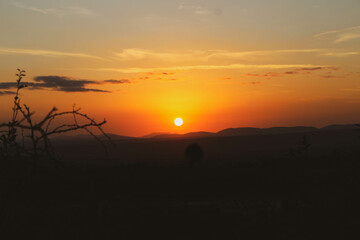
left=0, top=76, right=130, bottom=95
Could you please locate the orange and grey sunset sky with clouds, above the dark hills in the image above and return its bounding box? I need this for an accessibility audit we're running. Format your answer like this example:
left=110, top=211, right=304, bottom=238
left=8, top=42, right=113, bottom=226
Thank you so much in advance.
left=0, top=0, right=360, bottom=136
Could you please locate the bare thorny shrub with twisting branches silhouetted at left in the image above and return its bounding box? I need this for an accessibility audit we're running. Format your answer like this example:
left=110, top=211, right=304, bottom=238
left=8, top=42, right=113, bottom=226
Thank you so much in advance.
left=0, top=69, right=111, bottom=168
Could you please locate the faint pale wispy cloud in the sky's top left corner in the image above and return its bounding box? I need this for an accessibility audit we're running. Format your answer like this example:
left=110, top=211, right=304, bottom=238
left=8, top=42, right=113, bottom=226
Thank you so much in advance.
left=12, top=2, right=96, bottom=16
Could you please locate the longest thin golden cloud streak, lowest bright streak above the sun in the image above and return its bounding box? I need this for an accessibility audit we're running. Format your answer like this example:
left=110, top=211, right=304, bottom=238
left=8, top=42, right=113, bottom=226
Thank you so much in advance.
left=88, top=64, right=330, bottom=73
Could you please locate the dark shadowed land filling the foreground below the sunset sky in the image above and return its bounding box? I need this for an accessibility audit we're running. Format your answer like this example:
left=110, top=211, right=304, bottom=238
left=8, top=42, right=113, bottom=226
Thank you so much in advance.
left=0, top=127, right=360, bottom=239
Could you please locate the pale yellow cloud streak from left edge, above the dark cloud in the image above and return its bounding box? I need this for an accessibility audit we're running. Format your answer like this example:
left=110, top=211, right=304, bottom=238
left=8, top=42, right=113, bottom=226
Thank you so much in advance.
left=0, top=47, right=106, bottom=61
